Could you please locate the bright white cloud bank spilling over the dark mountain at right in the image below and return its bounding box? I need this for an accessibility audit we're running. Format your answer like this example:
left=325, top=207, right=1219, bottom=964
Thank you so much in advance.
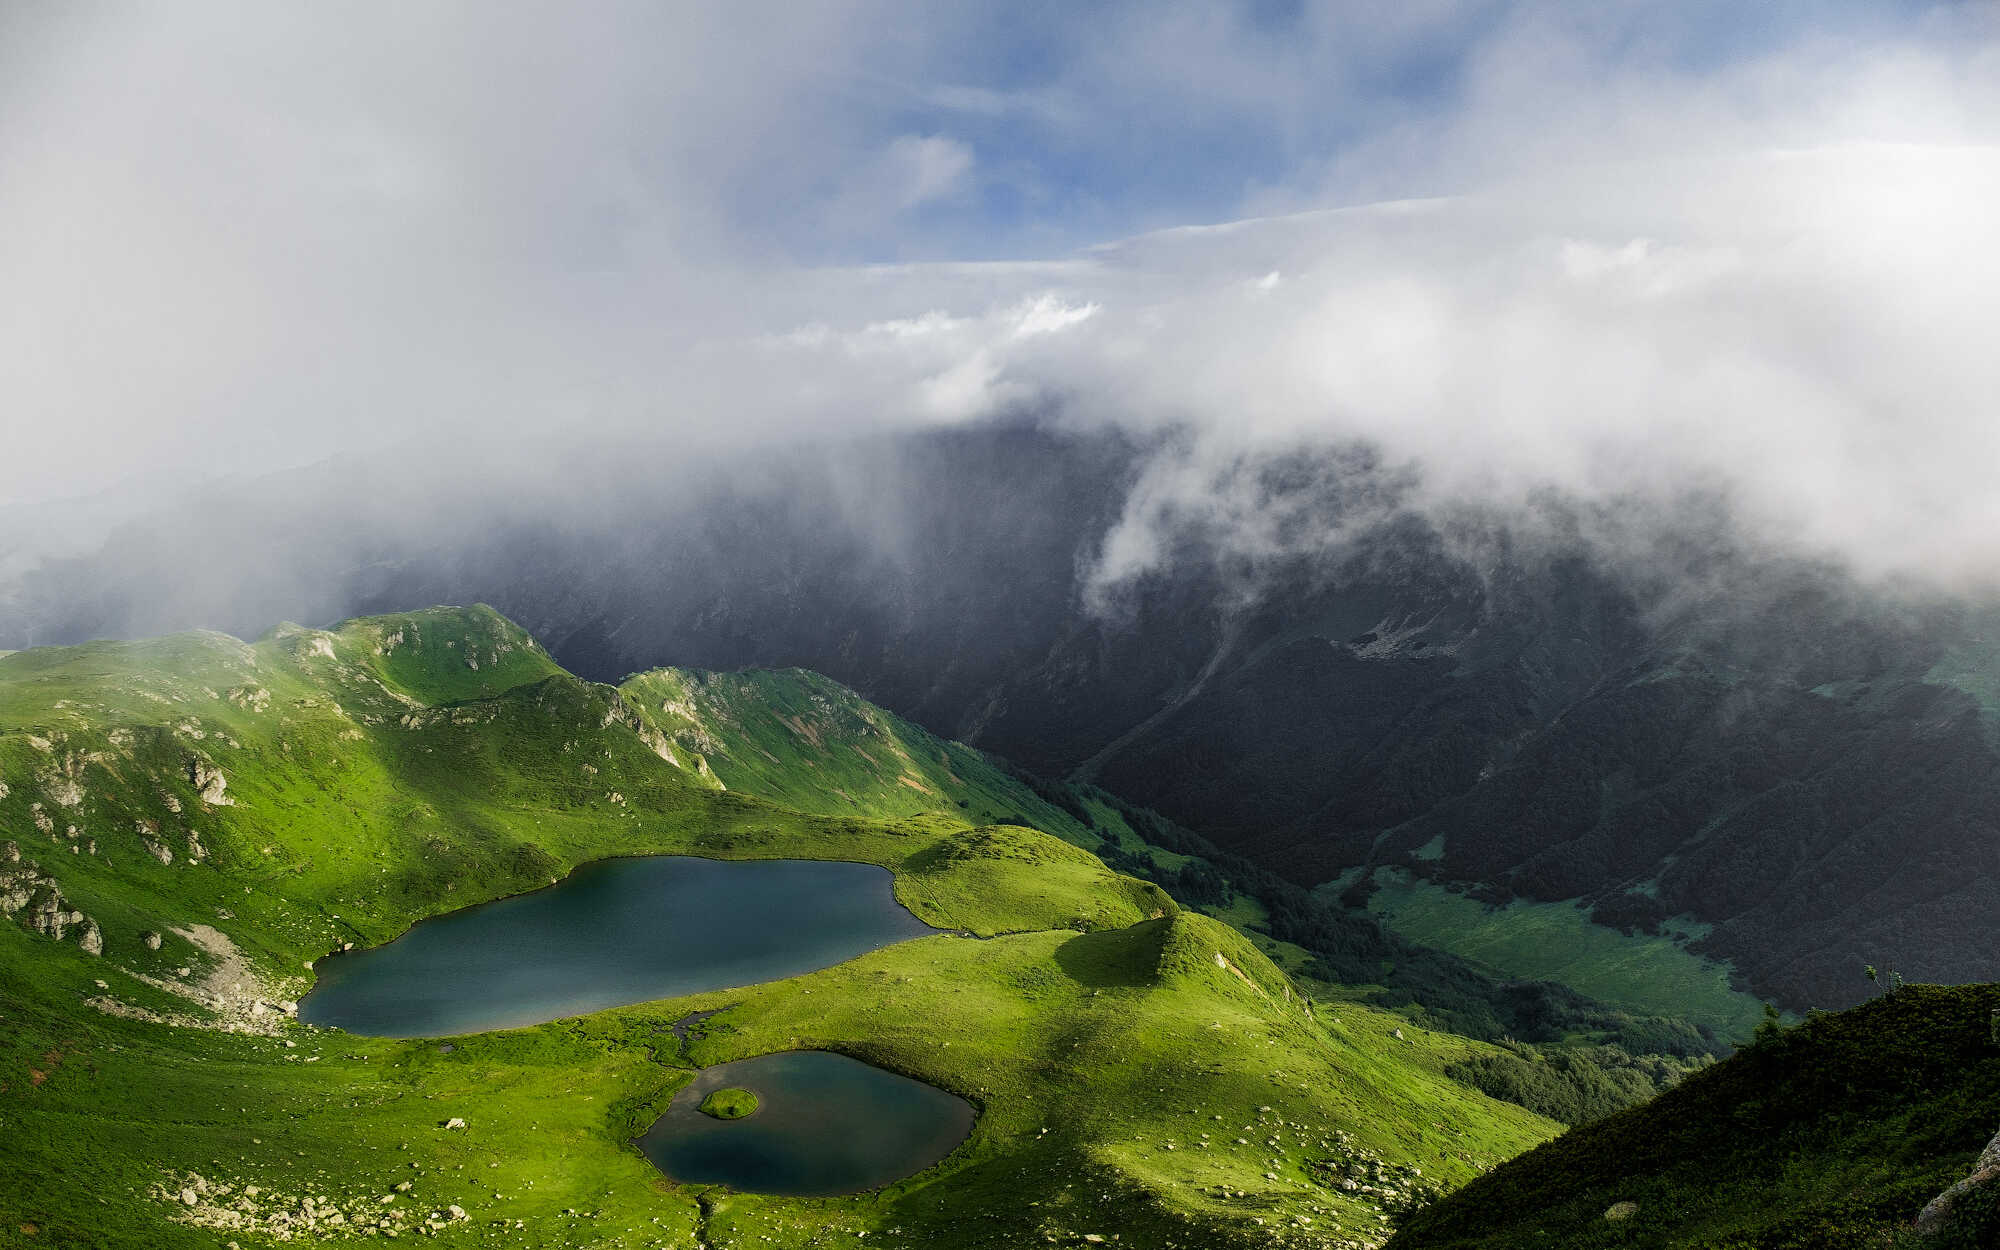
left=760, top=144, right=2000, bottom=584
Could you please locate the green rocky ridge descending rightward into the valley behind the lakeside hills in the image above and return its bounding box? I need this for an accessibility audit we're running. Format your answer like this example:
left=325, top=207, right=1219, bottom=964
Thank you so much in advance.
left=622, top=668, right=1728, bottom=1124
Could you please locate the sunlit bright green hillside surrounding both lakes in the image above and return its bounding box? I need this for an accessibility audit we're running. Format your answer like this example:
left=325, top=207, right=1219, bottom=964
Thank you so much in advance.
left=0, top=608, right=1556, bottom=1248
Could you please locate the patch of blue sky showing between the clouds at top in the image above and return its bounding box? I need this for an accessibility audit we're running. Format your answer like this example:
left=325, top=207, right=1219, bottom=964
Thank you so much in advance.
left=696, top=0, right=1958, bottom=262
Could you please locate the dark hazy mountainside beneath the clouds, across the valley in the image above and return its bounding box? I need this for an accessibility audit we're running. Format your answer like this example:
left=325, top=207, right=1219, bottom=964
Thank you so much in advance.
left=0, top=424, right=2000, bottom=1010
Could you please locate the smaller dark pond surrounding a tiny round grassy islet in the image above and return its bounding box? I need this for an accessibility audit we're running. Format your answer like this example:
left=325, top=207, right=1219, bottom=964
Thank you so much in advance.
left=638, top=1050, right=976, bottom=1198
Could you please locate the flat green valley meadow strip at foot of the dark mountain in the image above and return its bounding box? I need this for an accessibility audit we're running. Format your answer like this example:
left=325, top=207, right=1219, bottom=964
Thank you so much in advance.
left=1368, top=870, right=1764, bottom=1042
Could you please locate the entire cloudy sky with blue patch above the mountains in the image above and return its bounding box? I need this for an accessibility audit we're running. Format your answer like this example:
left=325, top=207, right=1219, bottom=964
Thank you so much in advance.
left=0, top=0, right=2000, bottom=584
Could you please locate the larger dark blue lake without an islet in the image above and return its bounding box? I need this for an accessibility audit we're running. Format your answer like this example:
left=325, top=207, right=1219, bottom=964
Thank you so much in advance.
left=298, top=856, right=938, bottom=1038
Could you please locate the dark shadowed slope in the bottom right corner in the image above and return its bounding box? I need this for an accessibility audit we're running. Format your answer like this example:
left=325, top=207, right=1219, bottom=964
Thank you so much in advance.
left=1390, top=986, right=2000, bottom=1250
